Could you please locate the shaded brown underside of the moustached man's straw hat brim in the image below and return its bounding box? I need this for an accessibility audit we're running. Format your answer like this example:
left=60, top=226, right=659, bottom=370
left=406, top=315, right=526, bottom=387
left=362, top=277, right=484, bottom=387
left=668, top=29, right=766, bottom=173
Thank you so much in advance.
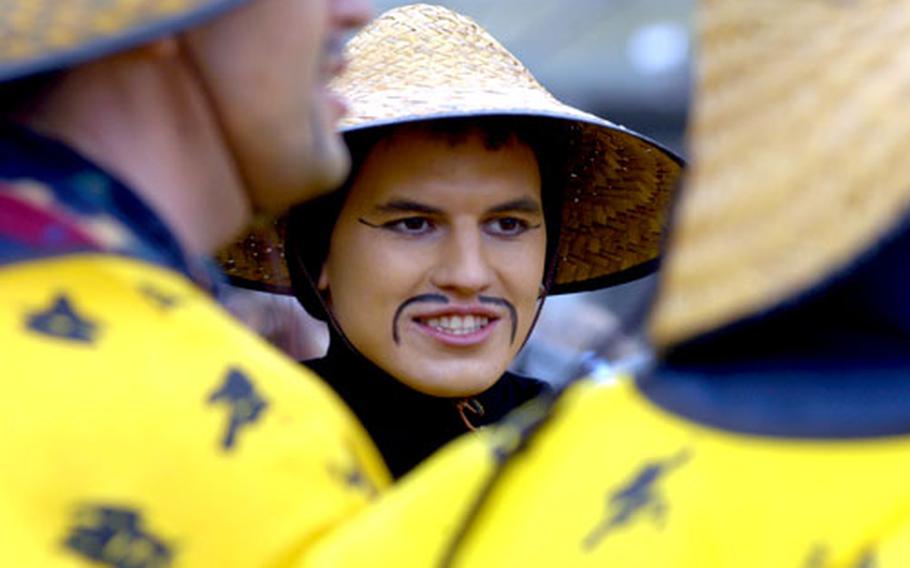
left=217, top=110, right=682, bottom=295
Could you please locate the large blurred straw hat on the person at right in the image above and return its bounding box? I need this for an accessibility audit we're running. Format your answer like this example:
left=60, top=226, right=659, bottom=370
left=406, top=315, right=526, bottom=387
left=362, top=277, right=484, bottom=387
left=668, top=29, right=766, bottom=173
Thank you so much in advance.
left=651, top=0, right=910, bottom=348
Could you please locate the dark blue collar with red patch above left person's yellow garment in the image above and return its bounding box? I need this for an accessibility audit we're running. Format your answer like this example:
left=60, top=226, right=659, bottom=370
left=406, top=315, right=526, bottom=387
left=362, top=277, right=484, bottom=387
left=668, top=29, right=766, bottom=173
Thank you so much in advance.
left=0, top=124, right=220, bottom=290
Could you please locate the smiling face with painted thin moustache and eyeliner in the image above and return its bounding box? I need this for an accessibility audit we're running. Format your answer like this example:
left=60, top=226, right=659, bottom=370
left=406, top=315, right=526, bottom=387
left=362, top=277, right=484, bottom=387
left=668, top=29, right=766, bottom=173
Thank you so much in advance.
left=319, top=128, right=546, bottom=397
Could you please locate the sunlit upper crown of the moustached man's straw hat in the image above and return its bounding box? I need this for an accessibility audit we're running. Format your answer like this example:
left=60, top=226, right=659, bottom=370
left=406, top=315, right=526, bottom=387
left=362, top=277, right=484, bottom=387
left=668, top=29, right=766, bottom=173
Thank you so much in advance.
left=332, top=4, right=572, bottom=128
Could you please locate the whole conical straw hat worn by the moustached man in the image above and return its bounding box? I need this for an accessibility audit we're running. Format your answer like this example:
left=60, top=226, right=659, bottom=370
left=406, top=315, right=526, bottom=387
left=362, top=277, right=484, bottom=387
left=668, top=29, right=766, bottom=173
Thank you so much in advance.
left=219, top=4, right=682, bottom=293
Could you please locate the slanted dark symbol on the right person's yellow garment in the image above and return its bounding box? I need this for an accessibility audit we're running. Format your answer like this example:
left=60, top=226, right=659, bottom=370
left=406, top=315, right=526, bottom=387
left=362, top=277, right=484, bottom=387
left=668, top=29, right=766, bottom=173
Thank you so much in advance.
left=582, top=450, right=689, bottom=550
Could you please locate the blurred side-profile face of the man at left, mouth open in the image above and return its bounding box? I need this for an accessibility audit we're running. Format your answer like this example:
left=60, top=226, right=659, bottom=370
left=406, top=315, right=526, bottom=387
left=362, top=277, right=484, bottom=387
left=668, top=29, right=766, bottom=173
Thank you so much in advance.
left=185, top=0, right=371, bottom=212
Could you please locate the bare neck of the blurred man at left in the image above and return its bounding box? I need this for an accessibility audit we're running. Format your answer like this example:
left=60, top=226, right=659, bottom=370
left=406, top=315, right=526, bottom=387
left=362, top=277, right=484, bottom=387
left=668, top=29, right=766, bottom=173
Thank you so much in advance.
left=27, top=49, right=250, bottom=254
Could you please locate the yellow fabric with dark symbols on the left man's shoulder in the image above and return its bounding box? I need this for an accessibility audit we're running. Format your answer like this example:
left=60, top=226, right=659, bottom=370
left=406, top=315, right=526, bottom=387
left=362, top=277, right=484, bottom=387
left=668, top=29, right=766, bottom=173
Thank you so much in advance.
left=0, top=255, right=389, bottom=567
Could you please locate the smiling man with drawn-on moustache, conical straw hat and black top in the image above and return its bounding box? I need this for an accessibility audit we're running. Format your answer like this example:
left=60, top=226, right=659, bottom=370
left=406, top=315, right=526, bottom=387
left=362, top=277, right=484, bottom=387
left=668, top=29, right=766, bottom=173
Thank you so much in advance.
left=216, top=4, right=681, bottom=477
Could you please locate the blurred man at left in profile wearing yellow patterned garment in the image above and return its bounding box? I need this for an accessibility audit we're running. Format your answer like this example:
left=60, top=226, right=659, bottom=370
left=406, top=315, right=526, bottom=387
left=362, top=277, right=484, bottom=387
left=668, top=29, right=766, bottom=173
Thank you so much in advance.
left=0, top=0, right=400, bottom=567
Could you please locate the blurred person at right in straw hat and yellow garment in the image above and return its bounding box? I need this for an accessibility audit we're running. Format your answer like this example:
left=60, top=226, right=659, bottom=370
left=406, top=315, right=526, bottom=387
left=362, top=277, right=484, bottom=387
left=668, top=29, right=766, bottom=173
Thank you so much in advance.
left=302, top=0, right=910, bottom=568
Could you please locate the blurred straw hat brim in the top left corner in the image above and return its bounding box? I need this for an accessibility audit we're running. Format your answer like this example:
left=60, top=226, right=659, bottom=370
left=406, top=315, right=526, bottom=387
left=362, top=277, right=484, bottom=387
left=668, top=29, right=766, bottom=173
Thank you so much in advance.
left=0, top=0, right=250, bottom=81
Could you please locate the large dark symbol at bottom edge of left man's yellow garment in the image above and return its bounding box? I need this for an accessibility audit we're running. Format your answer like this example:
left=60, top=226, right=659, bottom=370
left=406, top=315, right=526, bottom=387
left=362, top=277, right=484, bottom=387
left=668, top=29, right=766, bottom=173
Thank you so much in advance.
left=64, top=506, right=174, bottom=568
